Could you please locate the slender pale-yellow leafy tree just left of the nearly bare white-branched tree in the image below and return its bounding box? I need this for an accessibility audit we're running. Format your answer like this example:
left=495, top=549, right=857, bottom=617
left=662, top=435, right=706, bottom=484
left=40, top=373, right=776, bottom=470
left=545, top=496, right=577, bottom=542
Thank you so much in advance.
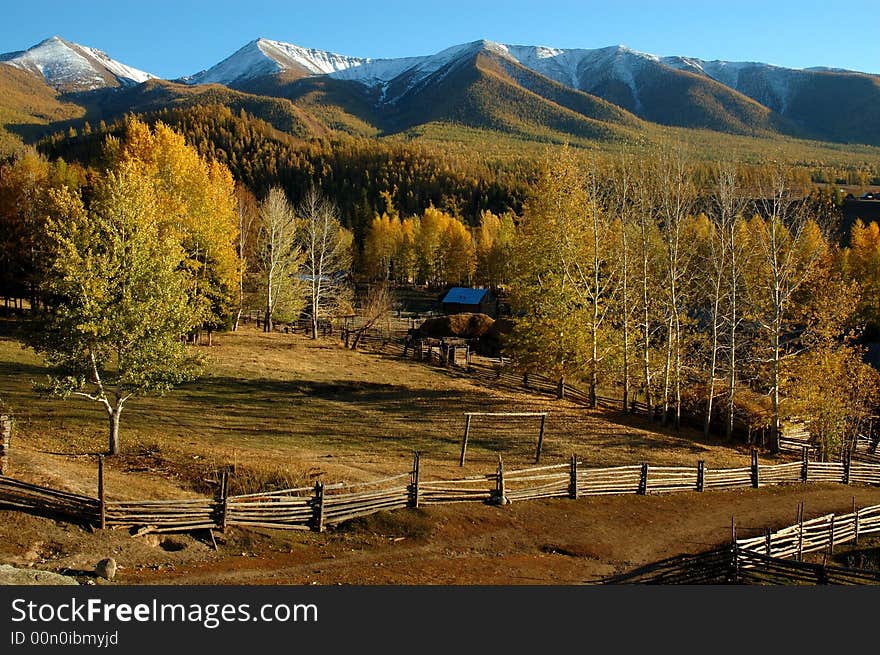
left=259, top=187, right=304, bottom=332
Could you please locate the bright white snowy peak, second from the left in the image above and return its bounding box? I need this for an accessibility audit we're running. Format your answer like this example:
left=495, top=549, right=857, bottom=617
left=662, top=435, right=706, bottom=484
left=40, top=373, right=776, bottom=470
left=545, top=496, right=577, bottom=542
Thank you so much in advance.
left=183, top=39, right=368, bottom=86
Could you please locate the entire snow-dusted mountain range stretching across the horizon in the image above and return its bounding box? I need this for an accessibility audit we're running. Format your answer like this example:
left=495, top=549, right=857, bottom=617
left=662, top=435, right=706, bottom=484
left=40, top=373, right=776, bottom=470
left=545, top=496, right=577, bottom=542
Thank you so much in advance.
left=0, top=36, right=880, bottom=144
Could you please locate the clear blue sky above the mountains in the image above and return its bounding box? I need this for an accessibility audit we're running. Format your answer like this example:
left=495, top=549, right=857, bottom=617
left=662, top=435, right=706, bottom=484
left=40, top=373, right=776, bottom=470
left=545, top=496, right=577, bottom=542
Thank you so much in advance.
left=0, top=0, right=880, bottom=78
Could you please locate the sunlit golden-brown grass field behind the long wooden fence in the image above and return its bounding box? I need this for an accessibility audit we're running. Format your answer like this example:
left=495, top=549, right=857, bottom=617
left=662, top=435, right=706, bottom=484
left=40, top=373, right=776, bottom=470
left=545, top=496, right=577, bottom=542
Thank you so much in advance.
left=0, top=322, right=748, bottom=498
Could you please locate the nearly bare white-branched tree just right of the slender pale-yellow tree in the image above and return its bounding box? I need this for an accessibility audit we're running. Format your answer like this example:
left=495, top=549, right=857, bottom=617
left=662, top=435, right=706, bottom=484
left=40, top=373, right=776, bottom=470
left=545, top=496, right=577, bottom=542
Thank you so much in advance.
left=298, top=187, right=351, bottom=339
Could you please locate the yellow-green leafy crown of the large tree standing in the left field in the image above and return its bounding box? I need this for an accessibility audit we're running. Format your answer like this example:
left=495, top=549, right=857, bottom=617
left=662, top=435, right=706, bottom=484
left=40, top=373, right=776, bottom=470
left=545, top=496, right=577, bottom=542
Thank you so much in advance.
left=27, top=165, right=205, bottom=394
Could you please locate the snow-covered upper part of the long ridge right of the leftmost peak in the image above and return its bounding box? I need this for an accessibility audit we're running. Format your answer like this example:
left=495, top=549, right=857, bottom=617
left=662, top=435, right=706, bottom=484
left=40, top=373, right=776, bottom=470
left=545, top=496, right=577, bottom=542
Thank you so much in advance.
left=184, top=39, right=872, bottom=114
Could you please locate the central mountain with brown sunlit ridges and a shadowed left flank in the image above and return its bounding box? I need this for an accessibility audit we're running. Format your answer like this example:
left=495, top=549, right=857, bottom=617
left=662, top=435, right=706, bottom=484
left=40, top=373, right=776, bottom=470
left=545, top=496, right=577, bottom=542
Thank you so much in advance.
left=223, top=41, right=643, bottom=140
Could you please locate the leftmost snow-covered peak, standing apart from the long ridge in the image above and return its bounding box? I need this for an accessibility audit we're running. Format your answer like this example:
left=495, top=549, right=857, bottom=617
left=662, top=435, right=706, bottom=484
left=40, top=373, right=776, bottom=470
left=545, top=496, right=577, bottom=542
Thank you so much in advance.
left=0, top=36, right=154, bottom=91
